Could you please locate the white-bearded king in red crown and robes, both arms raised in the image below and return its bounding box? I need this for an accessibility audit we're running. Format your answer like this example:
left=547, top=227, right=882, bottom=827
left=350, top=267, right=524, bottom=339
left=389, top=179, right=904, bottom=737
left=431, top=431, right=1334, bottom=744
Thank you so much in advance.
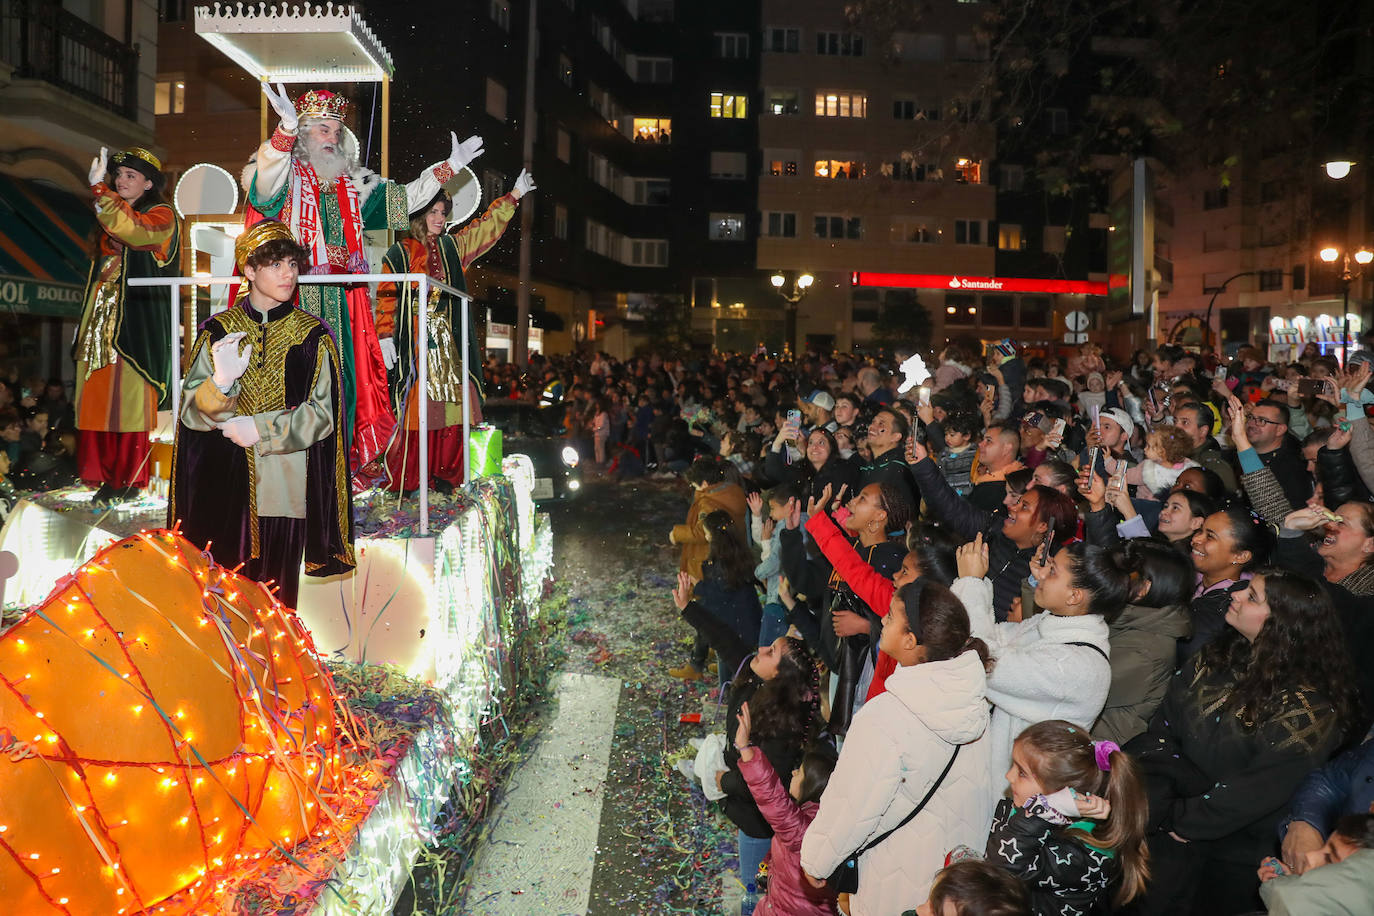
left=242, top=84, right=482, bottom=477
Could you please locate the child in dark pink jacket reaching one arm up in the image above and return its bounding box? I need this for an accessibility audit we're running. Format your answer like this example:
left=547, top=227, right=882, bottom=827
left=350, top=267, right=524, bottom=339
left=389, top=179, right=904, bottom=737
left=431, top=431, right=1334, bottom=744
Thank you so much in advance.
left=735, top=703, right=838, bottom=916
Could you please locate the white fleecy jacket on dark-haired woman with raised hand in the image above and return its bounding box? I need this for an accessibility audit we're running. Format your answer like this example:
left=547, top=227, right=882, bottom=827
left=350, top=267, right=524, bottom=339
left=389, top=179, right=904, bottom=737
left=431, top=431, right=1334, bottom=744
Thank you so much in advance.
left=952, top=575, right=1112, bottom=801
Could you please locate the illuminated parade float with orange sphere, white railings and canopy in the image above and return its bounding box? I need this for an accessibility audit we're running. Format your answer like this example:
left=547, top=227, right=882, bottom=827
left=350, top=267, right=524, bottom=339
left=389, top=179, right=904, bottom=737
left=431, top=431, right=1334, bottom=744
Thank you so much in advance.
left=0, top=4, right=552, bottom=915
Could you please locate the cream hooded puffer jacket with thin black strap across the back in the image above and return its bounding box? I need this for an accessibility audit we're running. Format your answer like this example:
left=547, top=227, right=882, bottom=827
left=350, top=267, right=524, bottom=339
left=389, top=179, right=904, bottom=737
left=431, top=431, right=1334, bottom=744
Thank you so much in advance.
left=801, top=651, right=992, bottom=916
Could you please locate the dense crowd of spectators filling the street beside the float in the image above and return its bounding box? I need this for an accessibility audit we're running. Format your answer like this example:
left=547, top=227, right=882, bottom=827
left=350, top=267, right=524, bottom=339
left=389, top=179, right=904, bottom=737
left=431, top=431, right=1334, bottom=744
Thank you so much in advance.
left=500, top=343, right=1374, bottom=916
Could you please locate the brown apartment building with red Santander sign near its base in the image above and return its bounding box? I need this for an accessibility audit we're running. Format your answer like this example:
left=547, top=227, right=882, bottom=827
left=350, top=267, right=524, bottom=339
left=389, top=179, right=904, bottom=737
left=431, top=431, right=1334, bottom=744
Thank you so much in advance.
left=752, top=0, right=996, bottom=349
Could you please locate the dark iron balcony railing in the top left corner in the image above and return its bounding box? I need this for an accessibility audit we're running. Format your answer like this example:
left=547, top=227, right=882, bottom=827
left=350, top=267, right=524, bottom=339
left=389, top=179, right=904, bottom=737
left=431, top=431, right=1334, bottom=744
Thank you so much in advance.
left=0, top=0, right=139, bottom=121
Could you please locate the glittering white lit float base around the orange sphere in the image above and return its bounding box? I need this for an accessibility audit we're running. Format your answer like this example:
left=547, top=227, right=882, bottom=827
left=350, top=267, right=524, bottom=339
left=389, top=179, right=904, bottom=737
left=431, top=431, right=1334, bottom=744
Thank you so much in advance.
left=0, top=455, right=552, bottom=916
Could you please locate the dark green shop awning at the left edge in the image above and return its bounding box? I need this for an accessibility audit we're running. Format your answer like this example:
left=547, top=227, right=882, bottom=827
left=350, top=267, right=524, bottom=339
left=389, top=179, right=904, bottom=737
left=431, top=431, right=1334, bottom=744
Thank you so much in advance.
left=0, top=174, right=95, bottom=319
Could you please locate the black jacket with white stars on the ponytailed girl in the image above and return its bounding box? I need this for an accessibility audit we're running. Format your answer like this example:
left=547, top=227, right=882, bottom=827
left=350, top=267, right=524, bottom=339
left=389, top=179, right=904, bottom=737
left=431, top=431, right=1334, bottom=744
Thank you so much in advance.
left=987, top=798, right=1121, bottom=916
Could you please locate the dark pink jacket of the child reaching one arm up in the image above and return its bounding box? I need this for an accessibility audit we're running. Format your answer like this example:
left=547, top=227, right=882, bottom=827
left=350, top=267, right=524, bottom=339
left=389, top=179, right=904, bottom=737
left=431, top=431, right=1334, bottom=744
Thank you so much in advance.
left=739, top=747, right=835, bottom=916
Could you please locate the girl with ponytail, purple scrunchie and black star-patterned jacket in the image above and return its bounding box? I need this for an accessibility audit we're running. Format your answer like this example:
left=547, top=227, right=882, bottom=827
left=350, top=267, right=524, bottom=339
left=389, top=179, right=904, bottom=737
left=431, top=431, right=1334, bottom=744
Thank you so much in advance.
left=988, top=720, right=1150, bottom=916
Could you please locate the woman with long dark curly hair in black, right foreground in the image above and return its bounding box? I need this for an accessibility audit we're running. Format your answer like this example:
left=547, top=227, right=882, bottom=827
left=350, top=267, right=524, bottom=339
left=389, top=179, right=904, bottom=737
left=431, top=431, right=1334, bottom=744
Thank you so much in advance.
left=1127, top=568, right=1356, bottom=916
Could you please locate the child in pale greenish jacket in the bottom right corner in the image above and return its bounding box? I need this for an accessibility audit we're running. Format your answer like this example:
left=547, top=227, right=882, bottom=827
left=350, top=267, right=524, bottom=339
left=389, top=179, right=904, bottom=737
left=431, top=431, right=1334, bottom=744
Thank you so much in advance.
left=1260, top=814, right=1374, bottom=916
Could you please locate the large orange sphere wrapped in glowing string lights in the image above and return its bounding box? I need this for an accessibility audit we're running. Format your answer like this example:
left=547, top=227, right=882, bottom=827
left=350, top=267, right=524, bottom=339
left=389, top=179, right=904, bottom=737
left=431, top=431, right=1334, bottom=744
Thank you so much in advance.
left=0, top=531, right=338, bottom=916
